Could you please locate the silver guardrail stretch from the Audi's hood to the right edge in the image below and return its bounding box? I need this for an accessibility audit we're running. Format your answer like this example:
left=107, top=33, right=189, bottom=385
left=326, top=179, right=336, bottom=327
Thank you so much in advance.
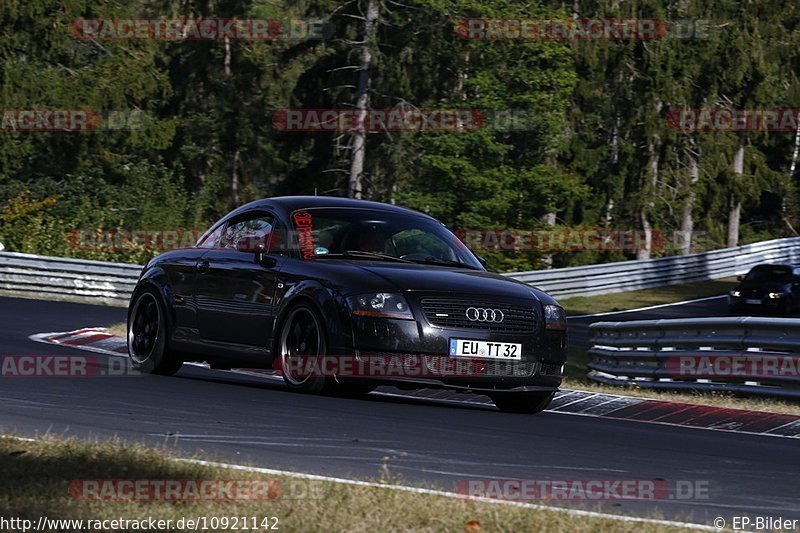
left=506, top=237, right=800, bottom=297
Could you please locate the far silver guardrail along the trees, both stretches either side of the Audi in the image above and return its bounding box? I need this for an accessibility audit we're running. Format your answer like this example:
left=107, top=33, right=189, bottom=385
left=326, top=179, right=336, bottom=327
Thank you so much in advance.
left=0, top=237, right=800, bottom=305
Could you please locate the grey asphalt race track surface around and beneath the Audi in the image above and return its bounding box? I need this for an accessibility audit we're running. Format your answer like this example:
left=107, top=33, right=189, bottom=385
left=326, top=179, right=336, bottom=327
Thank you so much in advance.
left=0, top=298, right=800, bottom=525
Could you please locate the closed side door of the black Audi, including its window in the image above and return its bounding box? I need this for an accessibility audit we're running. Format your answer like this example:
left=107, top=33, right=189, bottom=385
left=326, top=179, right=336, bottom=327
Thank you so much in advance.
left=195, top=211, right=283, bottom=348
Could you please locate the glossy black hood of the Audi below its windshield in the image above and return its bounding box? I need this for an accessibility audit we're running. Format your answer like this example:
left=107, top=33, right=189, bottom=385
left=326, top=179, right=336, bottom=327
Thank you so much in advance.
left=326, top=262, right=550, bottom=303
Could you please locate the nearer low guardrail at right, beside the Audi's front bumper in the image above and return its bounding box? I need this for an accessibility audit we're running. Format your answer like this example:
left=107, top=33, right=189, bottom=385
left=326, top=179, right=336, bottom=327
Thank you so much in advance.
left=588, top=317, right=800, bottom=398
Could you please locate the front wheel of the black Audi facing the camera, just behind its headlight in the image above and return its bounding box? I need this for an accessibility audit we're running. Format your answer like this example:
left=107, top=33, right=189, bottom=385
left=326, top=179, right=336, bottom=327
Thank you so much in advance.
left=277, top=303, right=333, bottom=394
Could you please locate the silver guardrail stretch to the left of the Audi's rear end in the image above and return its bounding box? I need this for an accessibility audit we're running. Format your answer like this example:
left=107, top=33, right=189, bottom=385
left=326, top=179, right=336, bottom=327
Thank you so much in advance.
left=0, top=252, right=142, bottom=306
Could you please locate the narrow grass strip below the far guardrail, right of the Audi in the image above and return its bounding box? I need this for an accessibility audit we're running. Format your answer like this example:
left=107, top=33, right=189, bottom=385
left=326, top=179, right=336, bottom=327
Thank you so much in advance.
left=558, top=278, right=738, bottom=316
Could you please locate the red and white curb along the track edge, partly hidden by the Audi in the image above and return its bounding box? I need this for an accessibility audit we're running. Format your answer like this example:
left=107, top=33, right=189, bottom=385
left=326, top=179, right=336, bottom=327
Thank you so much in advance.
left=30, top=328, right=800, bottom=438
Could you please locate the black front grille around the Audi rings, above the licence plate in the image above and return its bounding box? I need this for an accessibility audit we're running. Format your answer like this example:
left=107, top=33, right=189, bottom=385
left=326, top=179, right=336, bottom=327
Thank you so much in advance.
left=420, top=298, right=536, bottom=333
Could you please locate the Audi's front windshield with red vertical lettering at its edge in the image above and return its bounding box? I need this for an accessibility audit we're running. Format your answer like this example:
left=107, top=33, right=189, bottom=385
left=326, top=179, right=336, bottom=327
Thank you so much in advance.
left=292, top=207, right=483, bottom=270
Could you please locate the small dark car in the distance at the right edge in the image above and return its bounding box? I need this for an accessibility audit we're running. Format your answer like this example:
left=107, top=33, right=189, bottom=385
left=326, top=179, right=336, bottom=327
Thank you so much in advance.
left=728, top=264, right=800, bottom=315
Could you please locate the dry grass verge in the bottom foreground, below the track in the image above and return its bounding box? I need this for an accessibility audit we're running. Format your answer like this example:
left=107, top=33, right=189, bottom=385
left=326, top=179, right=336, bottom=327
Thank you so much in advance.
left=0, top=437, right=700, bottom=533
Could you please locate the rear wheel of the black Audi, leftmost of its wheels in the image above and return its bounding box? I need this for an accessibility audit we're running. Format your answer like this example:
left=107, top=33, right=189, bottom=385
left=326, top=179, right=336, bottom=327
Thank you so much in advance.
left=128, top=287, right=183, bottom=376
